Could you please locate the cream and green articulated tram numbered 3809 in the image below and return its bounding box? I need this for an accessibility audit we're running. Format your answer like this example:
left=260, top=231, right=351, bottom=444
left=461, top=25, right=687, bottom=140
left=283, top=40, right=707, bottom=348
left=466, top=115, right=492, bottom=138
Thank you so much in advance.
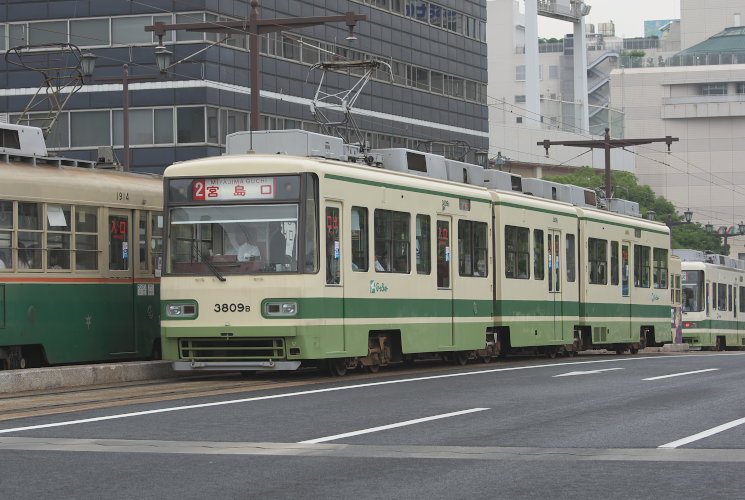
left=161, top=131, right=672, bottom=375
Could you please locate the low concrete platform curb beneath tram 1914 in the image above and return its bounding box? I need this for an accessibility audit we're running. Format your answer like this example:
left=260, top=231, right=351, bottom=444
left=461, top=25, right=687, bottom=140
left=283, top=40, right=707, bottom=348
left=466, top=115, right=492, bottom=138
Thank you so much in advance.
left=0, top=361, right=182, bottom=394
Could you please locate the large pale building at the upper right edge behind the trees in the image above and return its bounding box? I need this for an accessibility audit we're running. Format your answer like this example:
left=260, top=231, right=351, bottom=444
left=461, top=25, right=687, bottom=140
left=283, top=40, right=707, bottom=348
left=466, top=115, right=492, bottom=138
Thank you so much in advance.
left=611, top=0, right=745, bottom=255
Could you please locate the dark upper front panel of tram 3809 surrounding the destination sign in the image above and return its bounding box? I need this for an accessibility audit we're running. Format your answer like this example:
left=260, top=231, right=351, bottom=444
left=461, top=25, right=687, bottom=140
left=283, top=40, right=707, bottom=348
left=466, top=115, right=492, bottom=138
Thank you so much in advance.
left=168, top=175, right=300, bottom=203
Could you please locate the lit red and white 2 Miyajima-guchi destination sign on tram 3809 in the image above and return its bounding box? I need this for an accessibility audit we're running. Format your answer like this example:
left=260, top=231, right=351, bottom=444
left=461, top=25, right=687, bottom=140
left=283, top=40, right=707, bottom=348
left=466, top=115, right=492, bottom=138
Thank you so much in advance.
left=192, top=177, right=276, bottom=201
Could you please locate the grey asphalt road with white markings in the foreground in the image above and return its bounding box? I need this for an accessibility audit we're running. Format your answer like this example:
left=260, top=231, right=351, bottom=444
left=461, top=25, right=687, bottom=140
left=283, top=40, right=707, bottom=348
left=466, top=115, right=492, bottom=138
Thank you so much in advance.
left=0, top=353, right=745, bottom=499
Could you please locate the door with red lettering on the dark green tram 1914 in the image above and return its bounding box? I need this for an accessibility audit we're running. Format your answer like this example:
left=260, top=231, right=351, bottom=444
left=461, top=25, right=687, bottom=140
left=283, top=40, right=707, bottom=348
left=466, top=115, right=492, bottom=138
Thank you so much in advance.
left=107, top=210, right=137, bottom=354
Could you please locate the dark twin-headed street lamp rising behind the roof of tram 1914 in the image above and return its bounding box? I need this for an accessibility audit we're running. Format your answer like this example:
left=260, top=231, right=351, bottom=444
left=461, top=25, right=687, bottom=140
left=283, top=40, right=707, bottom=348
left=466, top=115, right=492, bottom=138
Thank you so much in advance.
left=80, top=43, right=173, bottom=172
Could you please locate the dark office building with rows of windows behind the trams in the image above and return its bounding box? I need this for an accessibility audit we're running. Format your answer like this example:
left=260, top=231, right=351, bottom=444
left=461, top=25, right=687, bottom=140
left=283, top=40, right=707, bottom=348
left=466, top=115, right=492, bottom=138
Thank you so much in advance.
left=0, top=0, right=488, bottom=173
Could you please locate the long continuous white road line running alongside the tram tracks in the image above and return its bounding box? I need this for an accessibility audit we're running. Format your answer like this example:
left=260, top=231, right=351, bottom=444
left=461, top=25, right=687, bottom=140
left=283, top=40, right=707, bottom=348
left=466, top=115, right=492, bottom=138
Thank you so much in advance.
left=0, top=353, right=745, bottom=434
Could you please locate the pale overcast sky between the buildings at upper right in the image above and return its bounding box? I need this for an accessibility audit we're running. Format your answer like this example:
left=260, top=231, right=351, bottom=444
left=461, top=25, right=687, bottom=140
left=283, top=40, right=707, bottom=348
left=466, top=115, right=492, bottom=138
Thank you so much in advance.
left=538, top=0, right=680, bottom=38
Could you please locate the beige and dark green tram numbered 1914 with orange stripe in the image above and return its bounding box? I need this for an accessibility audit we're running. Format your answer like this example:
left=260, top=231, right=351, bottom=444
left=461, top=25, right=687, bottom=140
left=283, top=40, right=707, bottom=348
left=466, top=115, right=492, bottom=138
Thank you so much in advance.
left=0, top=124, right=163, bottom=369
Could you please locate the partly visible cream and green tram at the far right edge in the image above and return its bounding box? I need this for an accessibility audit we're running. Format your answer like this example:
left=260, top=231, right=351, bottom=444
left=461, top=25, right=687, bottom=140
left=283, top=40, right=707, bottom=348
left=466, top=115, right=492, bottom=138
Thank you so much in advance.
left=674, top=250, right=745, bottom=351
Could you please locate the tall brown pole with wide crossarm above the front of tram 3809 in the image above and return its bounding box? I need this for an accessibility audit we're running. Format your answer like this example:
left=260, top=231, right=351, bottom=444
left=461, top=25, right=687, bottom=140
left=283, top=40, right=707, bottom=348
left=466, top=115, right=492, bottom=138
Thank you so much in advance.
left=145, top=0, right=367, bottom=130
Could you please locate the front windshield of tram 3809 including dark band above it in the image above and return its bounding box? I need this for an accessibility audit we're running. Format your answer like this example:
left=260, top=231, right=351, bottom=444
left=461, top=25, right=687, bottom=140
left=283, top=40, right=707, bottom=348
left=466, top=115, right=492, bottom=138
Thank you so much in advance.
left=167, top=177, right=317, bottom=279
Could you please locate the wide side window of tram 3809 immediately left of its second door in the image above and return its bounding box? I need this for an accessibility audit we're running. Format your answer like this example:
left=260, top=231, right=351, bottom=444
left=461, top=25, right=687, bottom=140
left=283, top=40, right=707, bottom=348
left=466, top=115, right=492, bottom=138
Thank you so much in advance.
left=375, top=210, right=411, bottom=273
